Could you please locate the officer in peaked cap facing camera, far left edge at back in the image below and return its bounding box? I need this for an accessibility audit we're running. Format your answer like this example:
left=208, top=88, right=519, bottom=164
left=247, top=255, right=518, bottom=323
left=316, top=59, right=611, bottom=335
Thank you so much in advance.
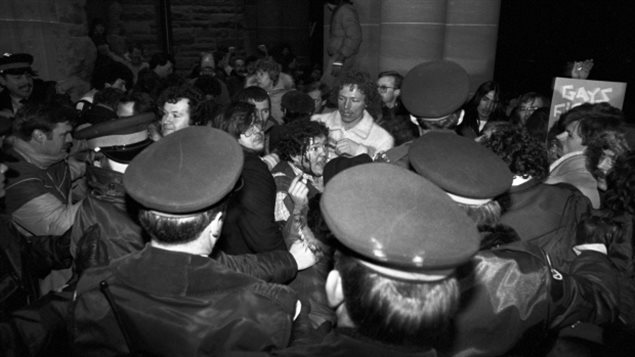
left=0, top=53, right=55, bottom=118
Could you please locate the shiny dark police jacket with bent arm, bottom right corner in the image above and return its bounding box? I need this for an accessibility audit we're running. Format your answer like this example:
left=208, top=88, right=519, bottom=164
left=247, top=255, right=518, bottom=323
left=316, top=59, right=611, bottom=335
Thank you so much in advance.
left=439, top=242, right=618, bottom=356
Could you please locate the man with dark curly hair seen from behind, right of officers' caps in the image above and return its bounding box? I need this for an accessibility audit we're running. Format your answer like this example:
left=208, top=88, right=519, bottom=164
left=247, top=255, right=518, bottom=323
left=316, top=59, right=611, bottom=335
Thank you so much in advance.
left=478, top=123, right=591, bottom=268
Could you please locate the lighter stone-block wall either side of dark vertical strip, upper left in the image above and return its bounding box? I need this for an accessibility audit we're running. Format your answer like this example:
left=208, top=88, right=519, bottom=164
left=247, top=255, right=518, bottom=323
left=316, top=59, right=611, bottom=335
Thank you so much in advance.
left=86, top=0, right=248, bottom=74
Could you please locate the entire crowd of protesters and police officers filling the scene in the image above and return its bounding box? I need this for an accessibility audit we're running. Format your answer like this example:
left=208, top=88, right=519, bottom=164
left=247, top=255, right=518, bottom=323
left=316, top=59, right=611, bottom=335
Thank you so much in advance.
left=0, top=2, right=635, bottom=356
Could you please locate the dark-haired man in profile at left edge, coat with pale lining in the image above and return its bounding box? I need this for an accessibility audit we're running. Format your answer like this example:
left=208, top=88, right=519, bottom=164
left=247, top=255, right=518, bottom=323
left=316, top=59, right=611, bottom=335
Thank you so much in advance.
left=5, top=105, right=85, bottom=293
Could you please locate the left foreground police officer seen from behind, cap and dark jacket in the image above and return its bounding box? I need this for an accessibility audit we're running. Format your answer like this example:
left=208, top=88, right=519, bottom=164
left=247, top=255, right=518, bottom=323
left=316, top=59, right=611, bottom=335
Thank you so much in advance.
left=73, top=127, right=301, bottom=356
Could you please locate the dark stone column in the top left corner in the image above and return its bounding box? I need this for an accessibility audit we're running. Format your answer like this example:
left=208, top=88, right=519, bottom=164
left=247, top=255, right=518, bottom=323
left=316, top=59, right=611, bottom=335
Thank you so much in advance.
left=0, top=0, right=97, bottom=81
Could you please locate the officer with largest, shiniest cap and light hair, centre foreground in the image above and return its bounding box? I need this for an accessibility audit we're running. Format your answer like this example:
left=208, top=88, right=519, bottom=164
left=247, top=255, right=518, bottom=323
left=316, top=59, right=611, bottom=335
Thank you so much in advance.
left=280, top=163, right=479, bottom=356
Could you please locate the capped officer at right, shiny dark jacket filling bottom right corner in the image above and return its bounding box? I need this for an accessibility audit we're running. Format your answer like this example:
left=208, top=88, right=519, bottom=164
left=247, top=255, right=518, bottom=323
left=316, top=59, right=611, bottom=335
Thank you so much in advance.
left=409, top=131, right=619, bottom=356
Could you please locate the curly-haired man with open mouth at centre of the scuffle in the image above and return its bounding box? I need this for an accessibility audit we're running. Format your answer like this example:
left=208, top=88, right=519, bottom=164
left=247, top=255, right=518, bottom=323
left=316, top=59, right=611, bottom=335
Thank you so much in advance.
left=271, top=120, right=329, bottom=222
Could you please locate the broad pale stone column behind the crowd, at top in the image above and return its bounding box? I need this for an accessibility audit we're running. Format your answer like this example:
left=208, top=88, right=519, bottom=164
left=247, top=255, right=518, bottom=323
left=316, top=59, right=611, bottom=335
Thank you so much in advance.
left=324, top=0, right=500, bottom=90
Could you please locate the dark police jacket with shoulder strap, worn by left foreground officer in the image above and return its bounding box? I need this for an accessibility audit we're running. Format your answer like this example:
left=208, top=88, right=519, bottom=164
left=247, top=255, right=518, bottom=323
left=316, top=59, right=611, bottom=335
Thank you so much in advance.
left=71, top=246, right=304, bottom=356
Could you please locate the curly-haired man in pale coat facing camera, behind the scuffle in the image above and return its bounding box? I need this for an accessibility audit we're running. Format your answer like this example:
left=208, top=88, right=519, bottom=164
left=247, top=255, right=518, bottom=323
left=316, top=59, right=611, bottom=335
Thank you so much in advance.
left=311, top=71, right=394, bottom=159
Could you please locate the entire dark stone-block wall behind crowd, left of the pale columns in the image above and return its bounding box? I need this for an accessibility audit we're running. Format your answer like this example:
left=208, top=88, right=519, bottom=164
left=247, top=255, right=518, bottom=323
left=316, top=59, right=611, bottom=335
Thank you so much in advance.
left=86, top=0, right=312, bottom=74
